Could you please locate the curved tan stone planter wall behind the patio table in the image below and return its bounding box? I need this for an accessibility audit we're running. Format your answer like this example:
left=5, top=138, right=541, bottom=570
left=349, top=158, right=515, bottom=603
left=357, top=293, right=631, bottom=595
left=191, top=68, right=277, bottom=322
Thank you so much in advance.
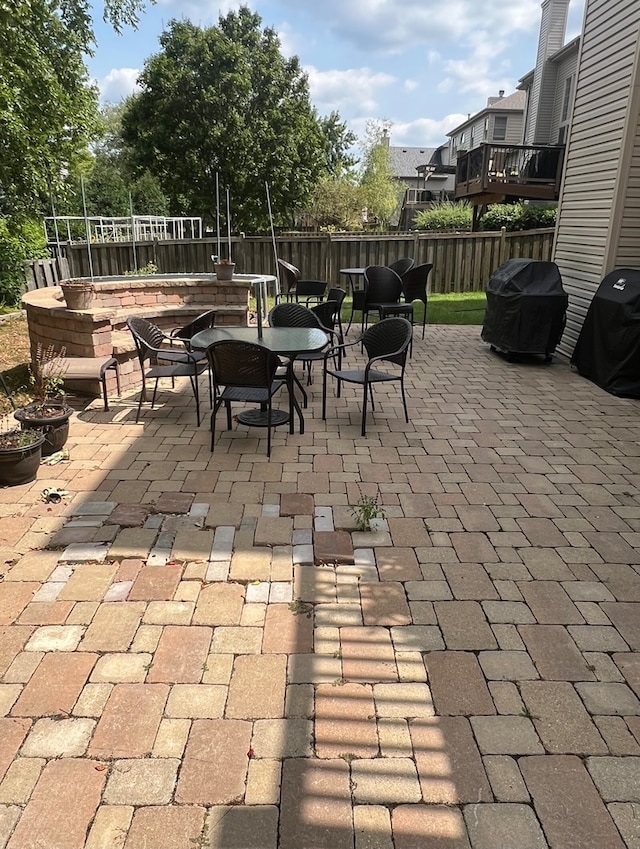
left=22, top=274, right=251, bottom=395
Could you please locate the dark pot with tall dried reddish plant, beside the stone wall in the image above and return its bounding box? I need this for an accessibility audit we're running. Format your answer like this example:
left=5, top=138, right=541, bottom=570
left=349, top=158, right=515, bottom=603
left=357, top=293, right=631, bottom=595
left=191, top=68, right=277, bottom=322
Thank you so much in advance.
left=13, top=344, right=73, bottom=457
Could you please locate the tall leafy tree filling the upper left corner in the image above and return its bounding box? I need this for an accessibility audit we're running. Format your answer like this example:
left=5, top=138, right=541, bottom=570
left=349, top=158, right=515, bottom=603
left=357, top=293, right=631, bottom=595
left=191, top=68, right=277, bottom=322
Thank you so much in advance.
left=0, top=0, right=148, bottom=216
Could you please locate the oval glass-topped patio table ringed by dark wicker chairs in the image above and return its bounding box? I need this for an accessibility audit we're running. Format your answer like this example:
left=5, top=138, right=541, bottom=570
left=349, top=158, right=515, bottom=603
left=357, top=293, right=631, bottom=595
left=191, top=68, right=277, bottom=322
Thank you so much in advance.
left=191, top=327, right=329, bottom=433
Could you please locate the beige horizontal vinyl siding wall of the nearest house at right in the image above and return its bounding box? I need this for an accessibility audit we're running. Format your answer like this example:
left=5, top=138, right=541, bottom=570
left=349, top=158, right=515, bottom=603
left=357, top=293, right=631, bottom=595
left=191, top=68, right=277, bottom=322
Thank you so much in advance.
left=554, top=0, right=640, bottom=355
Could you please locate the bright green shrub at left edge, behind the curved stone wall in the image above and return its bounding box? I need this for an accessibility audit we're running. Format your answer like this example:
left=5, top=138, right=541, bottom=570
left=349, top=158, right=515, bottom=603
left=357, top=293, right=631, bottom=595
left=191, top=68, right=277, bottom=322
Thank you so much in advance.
left=0, top=217, right=48, bottom=307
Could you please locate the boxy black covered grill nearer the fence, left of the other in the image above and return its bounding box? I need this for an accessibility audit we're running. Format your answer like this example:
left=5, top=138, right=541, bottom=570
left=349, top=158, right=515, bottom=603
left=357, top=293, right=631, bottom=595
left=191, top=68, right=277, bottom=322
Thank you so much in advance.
left=482, top=259, right=569, bottom=357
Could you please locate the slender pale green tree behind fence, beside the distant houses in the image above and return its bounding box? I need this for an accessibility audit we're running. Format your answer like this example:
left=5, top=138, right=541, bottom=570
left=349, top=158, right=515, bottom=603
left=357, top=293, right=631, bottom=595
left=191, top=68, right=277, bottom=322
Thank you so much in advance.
left=360, top=121, right=405, bottom=229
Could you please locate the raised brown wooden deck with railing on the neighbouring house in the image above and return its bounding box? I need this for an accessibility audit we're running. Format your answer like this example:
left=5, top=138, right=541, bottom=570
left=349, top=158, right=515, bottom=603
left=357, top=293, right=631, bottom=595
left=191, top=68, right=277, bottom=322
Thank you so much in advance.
left=456, top=144, right=564, bottom=202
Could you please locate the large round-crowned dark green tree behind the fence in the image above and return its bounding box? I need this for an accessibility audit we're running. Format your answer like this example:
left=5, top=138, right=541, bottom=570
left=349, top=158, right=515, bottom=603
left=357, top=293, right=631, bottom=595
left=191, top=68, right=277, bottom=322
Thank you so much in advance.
left=123, top=7, right=326, bottom=230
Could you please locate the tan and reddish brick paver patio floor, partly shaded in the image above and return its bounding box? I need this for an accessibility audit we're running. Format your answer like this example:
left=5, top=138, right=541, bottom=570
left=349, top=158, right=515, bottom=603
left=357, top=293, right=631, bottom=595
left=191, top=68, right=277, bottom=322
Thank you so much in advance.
left=0, top=327, right=640, bottom=849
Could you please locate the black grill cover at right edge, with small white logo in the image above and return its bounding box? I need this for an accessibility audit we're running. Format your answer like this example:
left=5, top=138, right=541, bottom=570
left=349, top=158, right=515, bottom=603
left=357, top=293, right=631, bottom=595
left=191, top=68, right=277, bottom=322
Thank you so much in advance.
left=571, top=268, right=640, bottom=398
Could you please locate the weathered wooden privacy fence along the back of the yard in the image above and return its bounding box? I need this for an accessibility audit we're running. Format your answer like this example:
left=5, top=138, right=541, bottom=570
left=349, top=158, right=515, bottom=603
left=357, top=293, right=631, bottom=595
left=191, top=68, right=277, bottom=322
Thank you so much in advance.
left=41, top=228, right=554, bottom=293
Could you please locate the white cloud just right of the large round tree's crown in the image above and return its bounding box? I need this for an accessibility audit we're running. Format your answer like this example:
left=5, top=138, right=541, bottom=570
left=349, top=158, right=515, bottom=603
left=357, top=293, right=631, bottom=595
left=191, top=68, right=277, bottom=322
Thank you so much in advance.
left=305, top=65, right=397, bottom=115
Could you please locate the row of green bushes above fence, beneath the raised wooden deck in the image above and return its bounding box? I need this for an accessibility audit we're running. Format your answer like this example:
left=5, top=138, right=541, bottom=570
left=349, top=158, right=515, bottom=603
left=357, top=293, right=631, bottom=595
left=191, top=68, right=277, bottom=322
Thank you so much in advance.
left=415, top=201, right=556, bottom=232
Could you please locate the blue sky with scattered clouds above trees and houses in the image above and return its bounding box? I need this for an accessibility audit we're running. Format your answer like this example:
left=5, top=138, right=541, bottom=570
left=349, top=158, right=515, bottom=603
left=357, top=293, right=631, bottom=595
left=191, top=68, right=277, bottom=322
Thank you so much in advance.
left=88, top=0, right=584, bottom=147
